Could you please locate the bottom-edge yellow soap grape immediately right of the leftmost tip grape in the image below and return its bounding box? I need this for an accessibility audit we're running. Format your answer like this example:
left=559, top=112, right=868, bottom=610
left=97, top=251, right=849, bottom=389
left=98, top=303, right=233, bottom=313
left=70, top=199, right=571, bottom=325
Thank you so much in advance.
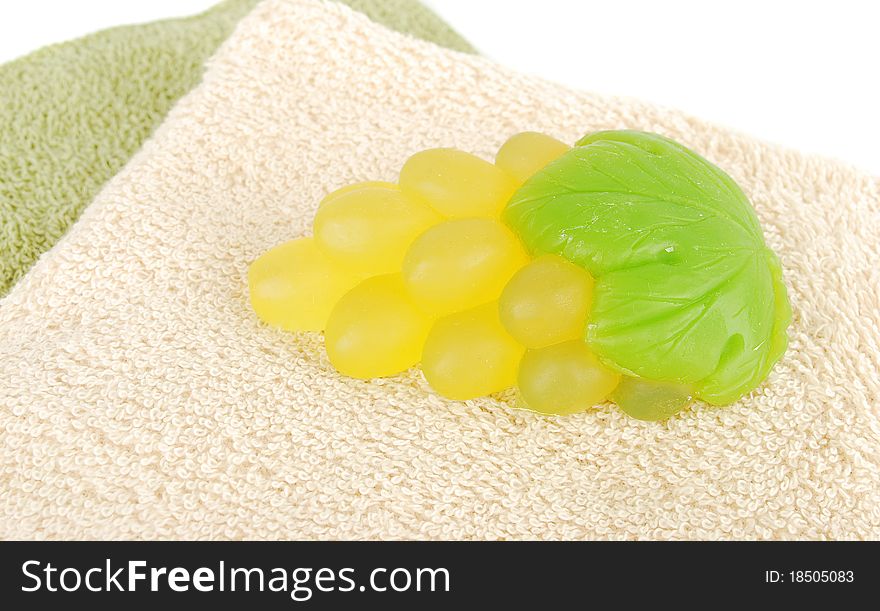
left=324, top=274, right=431, bottom=379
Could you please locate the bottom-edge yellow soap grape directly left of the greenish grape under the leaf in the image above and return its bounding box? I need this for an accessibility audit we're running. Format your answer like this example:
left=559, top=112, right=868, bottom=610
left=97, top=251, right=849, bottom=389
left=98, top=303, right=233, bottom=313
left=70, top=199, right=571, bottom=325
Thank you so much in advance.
left=517, top=339, right=620, bottom=415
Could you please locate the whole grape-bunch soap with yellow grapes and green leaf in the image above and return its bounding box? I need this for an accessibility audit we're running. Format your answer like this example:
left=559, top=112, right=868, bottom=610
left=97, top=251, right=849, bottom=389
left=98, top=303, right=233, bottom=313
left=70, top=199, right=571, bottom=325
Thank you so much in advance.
left=249, top=131, right=791, bottom=421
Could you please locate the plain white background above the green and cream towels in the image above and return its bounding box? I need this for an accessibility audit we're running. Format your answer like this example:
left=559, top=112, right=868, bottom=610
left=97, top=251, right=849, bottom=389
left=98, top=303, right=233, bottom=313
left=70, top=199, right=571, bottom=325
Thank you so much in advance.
left=0, top=0, right=880, bottom=174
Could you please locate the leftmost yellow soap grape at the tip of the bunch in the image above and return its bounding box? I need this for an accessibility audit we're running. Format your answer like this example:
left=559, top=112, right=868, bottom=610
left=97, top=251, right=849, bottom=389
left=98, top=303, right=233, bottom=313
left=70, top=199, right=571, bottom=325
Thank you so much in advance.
left=248, top=238, right=358, bottom=331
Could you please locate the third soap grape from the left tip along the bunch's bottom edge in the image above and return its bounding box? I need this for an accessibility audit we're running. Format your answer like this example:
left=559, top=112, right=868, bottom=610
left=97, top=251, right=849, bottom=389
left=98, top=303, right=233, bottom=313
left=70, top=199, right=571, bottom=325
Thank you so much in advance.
left=422, top=302, right=525, bottom=400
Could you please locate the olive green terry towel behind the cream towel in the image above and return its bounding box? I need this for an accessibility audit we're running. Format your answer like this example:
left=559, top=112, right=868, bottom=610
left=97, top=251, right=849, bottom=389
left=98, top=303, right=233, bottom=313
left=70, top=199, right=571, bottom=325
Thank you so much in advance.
left=0, top=0, right=471, bottom=296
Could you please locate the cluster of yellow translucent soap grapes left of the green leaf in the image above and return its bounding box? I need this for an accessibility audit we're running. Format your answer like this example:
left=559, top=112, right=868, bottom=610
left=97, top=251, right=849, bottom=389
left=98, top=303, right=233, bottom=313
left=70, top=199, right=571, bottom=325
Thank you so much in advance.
left=249, top=132, right=620, bottom=414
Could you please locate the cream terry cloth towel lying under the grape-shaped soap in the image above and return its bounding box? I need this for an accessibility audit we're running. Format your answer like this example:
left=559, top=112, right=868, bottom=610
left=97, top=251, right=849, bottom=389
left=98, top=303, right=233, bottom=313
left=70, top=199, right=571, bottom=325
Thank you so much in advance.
left=0, top=0, right=880, bottom=539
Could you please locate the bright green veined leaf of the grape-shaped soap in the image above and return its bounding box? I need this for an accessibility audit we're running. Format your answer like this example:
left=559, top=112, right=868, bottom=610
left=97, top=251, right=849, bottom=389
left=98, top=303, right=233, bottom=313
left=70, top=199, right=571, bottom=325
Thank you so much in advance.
left=505, top=131, right=791, bottom=405
